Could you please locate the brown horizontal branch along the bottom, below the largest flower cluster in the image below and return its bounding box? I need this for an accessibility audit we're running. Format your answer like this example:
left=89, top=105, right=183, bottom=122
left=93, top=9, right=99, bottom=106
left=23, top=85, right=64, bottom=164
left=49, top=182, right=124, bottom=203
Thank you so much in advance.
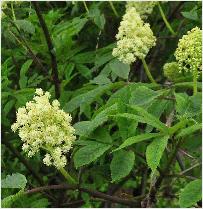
left=26, top=184, right=143, bottom=207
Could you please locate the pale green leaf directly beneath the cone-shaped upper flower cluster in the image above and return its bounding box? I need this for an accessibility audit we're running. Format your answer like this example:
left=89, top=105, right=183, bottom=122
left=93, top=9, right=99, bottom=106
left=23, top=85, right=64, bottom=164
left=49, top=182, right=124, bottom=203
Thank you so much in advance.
left=109, top=59, right=130, bottom=79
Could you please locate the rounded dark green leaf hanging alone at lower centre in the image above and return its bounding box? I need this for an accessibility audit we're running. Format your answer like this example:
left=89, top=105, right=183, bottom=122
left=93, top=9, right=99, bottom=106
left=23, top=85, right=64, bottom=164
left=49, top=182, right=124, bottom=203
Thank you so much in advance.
left=110, top=150, right=135, bottom=182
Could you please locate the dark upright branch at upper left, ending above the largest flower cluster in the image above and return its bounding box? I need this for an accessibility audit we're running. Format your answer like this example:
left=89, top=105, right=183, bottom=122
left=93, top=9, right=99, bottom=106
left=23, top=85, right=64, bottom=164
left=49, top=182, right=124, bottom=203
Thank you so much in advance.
left=32, top=1, right=60, bottom=99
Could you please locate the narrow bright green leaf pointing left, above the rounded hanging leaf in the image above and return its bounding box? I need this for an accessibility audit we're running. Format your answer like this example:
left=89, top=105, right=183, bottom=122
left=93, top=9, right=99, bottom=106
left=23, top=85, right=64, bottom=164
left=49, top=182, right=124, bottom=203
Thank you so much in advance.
left=113, top=133, right=161, bottom=152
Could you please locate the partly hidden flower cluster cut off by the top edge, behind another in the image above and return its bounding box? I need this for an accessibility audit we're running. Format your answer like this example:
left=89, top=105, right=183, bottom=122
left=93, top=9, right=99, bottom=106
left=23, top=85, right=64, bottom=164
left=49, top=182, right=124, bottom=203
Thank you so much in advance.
left=126, top=1, right=157, bottom=20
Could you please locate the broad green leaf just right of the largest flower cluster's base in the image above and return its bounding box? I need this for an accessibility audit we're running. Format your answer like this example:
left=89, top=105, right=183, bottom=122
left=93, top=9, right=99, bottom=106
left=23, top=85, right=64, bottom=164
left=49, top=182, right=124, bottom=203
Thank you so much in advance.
left=74, top=142, right=111, bottom=168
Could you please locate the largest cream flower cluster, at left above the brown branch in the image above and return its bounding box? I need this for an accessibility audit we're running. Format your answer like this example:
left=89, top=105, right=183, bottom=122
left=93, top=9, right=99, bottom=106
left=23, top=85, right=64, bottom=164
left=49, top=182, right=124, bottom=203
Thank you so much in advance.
left=11, top=89, right=76, bottom=169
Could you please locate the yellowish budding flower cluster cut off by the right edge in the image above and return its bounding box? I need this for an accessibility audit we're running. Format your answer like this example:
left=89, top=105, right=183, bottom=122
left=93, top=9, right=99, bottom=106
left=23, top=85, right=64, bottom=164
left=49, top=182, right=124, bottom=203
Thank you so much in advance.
left=175, top=27, right=202, bottom=76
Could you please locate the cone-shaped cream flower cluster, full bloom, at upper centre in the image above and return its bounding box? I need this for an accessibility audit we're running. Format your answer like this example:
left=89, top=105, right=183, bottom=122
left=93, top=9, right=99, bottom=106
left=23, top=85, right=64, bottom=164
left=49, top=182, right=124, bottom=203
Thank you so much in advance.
left=112, top=7, right=156, bottom=64
